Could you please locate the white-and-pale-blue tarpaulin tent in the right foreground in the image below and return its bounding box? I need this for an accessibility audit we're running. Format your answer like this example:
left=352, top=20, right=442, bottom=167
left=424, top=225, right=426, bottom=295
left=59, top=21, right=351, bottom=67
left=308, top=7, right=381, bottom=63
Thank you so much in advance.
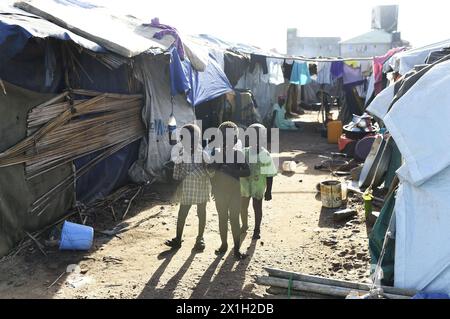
left=374, top=60, right=450, bottom=293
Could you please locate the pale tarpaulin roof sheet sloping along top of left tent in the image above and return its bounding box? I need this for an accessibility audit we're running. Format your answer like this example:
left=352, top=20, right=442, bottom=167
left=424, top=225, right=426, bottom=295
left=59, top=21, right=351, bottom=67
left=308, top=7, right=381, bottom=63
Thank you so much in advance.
left=14, top=0, right=207, bottom=71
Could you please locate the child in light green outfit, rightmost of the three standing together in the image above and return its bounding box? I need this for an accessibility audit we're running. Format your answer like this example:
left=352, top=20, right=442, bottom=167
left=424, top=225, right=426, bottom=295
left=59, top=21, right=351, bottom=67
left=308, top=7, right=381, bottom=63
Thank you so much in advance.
left=241, top=124, right=278, bottom=240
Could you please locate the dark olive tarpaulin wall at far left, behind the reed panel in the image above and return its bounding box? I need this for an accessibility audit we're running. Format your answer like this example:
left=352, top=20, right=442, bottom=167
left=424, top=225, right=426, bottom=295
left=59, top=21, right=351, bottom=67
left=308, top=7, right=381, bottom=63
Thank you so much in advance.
left=0, top=81, right=75, bottom=256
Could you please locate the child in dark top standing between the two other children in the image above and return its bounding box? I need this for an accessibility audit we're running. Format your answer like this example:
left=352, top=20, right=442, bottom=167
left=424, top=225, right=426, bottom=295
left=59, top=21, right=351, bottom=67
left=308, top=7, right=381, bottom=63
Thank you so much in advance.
left=212, top=122, right=250, bottom=260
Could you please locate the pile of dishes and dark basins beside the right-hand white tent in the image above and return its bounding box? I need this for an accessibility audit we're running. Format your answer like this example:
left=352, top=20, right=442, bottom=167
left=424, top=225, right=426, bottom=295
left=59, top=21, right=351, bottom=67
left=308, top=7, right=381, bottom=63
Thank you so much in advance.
left=338, top=113, right=379, bottom=162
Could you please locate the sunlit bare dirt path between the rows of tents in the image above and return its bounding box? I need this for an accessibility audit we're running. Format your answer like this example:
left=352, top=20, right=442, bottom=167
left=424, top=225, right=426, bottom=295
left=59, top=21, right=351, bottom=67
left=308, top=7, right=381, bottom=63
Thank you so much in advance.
left=0, top=114, right=369, bottom=298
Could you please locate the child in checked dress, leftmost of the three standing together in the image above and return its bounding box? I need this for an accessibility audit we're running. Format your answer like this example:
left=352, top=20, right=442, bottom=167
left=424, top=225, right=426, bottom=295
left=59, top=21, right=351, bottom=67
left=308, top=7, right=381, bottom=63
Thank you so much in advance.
left=165, top=124, right=211, bottom=251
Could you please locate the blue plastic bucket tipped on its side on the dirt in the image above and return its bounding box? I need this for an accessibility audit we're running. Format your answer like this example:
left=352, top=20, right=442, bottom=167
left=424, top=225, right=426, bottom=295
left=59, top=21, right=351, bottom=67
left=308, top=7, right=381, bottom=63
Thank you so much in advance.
left=59, top=221, right=94, bottom=250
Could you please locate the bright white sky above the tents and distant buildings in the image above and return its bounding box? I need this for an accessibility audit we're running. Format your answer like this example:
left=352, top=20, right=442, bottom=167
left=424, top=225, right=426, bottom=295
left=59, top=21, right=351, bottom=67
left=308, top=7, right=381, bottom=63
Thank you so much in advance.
left=77, top=0, right=450, bottom=53
